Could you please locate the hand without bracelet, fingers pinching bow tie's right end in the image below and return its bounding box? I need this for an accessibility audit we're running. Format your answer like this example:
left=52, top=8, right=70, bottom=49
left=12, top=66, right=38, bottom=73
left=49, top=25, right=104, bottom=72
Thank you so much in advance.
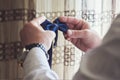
left=59, top=16, right=101, bottom=52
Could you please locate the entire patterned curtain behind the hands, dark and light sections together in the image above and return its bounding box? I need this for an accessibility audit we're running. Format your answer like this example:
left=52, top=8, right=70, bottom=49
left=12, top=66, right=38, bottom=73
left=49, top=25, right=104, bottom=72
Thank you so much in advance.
left=0, top=0, right=120, bottom=80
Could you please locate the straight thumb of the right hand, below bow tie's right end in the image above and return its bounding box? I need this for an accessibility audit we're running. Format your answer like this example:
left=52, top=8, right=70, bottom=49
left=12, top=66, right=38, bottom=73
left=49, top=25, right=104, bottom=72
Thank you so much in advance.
left=67, top=29, right=90, bottom=38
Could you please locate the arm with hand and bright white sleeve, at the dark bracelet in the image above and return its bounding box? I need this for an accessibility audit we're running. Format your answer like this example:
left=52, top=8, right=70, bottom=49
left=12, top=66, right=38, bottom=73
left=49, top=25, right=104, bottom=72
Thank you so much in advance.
left=20, top=17, right=58, bottom=80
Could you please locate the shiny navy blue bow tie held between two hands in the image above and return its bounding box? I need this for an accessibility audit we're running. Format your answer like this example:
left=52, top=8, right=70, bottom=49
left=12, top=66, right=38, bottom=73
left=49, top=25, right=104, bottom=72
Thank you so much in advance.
left=41, top=18, right=68, bottom=46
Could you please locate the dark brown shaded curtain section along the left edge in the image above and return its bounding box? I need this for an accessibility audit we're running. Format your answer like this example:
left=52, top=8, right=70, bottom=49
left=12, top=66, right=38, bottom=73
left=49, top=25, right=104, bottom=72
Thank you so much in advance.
left=0, top=0, right=36, bottom=80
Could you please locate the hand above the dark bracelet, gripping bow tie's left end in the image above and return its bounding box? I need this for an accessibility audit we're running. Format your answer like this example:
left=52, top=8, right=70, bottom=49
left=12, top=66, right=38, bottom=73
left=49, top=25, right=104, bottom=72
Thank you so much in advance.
left=20, top=17, right=55, bottom=51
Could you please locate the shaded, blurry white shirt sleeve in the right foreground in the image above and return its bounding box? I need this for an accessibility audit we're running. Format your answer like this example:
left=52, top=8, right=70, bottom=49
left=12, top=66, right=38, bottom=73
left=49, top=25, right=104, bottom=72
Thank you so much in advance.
left=73, top=15, right=120, bottom=80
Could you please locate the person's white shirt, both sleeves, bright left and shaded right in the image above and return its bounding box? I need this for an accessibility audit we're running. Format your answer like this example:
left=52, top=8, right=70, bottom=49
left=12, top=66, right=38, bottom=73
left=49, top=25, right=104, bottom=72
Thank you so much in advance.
left=23, top=15, right=120, bottom=80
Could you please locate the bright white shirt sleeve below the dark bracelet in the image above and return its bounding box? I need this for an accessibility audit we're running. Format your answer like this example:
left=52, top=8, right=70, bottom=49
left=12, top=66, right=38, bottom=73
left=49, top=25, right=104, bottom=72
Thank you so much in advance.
left=23, top=47, right=59, bottom=80
